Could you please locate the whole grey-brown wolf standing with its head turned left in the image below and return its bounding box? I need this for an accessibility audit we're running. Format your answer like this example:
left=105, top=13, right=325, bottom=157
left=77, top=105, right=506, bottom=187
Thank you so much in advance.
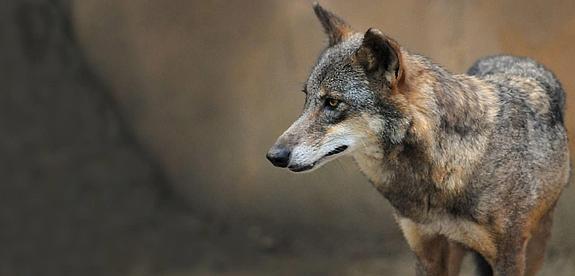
left=267, top=3, right=570, bottom=275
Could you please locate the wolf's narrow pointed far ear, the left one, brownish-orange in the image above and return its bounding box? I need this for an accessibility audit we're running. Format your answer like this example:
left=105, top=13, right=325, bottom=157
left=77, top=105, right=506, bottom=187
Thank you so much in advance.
left=313, top=2, right=352, bottom=46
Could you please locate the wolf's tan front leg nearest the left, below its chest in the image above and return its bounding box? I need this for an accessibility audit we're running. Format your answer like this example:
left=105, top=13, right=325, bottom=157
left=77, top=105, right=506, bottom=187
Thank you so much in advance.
left=398, top=219, right=465, bottom=276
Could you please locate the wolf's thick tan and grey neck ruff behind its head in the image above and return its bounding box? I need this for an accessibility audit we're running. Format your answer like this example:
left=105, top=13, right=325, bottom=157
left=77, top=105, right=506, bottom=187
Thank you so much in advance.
left=356, top=53, right=498, bottom=194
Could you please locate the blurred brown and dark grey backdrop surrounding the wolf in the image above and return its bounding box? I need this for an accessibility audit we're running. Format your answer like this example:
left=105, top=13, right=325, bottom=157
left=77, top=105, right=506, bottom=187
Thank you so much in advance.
left=0, top=0, right=575, bottom=276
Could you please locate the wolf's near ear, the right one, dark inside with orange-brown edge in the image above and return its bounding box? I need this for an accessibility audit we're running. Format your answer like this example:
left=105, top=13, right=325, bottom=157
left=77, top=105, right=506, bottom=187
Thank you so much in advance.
left=356, top=28, right=404, bottom=86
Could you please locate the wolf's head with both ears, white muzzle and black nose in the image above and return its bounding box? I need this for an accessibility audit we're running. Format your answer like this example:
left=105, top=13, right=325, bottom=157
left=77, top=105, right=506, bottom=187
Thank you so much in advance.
left=267, top=4, right=409, bottom=172
